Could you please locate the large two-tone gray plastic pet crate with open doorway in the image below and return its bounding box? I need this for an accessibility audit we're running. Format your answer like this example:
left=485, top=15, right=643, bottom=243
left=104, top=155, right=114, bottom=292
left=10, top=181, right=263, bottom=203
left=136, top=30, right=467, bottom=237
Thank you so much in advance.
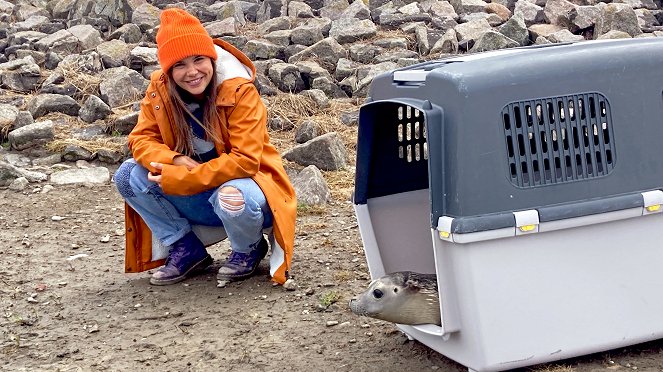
left=354, top=38, right=663, bottom=371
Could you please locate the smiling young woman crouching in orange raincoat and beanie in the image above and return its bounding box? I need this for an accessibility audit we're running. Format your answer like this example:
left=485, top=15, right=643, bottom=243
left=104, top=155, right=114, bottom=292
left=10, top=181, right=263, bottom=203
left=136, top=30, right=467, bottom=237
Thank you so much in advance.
left=114, top=8, right=297, bottom=285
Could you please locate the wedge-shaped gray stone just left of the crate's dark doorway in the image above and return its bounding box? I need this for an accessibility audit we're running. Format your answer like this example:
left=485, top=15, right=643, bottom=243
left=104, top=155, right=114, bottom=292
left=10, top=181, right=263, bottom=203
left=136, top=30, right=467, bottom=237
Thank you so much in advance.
left=283, top=132, right=348, bottom=170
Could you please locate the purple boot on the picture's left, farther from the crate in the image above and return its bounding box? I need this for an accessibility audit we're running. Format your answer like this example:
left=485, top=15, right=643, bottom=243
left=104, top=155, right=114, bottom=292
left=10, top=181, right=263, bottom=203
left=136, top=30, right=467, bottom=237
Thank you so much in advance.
left=150, top=231, right=214, bottom=285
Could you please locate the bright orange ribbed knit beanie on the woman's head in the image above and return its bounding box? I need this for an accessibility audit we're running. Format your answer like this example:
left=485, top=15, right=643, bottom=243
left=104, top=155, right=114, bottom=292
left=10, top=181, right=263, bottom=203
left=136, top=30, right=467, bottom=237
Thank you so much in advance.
left=157, top=8, right=217, bottom=71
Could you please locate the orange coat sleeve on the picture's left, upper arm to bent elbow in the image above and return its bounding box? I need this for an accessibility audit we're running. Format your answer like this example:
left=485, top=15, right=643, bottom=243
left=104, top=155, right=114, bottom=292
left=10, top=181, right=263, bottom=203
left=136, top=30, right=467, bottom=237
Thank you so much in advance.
left=128, top=87, right=180, bottom=171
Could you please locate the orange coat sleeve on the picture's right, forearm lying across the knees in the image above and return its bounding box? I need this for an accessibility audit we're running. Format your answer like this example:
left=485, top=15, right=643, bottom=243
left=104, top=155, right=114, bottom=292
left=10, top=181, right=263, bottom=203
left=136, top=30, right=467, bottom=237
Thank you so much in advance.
left=161, top=82, right=267, bottom=195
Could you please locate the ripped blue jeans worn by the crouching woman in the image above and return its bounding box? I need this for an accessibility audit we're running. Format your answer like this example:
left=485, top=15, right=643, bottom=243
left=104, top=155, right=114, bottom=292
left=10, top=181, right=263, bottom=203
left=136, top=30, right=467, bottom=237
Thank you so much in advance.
left=113, top=159, right=272, bottom=253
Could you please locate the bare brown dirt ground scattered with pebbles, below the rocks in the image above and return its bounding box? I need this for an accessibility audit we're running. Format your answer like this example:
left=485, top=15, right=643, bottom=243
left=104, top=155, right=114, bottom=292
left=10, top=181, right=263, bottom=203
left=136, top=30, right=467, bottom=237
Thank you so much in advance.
left=0, top=166, right=663, bottom=372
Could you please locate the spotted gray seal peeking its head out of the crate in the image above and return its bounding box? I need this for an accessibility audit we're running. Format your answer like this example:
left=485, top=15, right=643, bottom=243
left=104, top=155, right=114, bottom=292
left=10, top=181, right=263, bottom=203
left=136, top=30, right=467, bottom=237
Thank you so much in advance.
left=350, top=271, right=442, bottom=325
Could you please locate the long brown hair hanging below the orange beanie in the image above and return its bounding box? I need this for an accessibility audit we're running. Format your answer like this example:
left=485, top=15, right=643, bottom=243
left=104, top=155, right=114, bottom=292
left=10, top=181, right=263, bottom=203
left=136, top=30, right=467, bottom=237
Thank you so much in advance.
left=167, top=60, right=227, bottom=156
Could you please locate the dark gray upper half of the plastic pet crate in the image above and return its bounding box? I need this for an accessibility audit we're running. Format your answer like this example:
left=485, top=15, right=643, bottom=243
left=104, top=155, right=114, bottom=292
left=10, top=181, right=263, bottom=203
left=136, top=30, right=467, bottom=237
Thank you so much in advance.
left=355, top=38, right=663, bottom=227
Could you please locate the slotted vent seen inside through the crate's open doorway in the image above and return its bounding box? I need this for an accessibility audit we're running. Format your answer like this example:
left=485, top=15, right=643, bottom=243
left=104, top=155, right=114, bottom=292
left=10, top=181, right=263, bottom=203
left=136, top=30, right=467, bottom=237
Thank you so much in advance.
left=396, top=105, right=428, bottom=163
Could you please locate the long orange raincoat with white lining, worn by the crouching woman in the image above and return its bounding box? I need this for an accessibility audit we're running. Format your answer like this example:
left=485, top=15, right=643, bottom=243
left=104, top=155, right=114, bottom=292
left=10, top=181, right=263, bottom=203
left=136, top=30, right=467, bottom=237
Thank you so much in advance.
left=125, top=40, right=297, bottom=284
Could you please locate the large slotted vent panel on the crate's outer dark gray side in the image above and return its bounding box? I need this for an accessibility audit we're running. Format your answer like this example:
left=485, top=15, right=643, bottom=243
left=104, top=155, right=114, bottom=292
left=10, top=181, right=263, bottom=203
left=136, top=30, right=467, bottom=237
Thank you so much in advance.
left=502, top=93, right=615, bottom=187
